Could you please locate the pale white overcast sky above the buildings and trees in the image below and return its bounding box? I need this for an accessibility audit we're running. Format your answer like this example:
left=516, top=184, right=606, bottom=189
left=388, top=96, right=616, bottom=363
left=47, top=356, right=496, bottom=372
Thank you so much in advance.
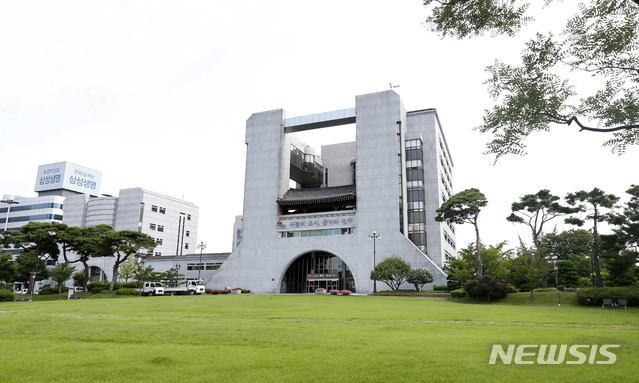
left=0, top=0, right=639, bottom=252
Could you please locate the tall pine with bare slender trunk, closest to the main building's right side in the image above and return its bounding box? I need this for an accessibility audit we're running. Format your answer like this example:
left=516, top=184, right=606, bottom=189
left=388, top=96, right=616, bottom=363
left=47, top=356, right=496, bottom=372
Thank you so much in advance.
left=435, top=188, right=488, bottom=276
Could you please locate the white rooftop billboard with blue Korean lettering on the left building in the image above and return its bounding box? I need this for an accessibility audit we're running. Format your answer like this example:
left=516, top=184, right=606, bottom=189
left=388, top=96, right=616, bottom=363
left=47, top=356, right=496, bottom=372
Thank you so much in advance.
left=34, top=162, right=102, bottom=196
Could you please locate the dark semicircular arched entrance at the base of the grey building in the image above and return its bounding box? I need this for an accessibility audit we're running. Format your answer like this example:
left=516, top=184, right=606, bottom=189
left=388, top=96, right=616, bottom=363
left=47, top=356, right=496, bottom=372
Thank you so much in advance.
left=280, top=251, right=355, bottom=293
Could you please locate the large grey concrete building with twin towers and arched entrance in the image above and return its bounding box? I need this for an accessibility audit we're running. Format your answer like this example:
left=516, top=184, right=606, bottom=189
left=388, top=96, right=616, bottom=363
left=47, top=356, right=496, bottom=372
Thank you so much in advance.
left=209, top=91, right=456, bottom=293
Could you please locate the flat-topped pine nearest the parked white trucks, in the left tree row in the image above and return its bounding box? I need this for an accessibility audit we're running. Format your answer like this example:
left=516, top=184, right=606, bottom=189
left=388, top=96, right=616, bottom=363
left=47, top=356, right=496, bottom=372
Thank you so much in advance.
left=100, top=230, right=157, bottom=291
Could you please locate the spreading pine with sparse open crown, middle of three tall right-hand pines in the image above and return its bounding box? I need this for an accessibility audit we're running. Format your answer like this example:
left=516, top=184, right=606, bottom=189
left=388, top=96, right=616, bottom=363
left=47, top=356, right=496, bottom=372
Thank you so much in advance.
left=506, top=189, right=577, bottom=287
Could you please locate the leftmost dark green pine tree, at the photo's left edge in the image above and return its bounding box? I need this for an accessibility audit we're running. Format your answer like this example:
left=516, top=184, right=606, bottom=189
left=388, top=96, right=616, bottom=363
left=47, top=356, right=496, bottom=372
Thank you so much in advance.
left=3, top=222, right=66, bottom=294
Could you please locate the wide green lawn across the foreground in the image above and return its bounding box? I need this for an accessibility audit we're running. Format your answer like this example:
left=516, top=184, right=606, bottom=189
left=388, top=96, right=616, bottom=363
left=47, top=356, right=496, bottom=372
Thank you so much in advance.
left=0, top=292, right=639, bottom=382
